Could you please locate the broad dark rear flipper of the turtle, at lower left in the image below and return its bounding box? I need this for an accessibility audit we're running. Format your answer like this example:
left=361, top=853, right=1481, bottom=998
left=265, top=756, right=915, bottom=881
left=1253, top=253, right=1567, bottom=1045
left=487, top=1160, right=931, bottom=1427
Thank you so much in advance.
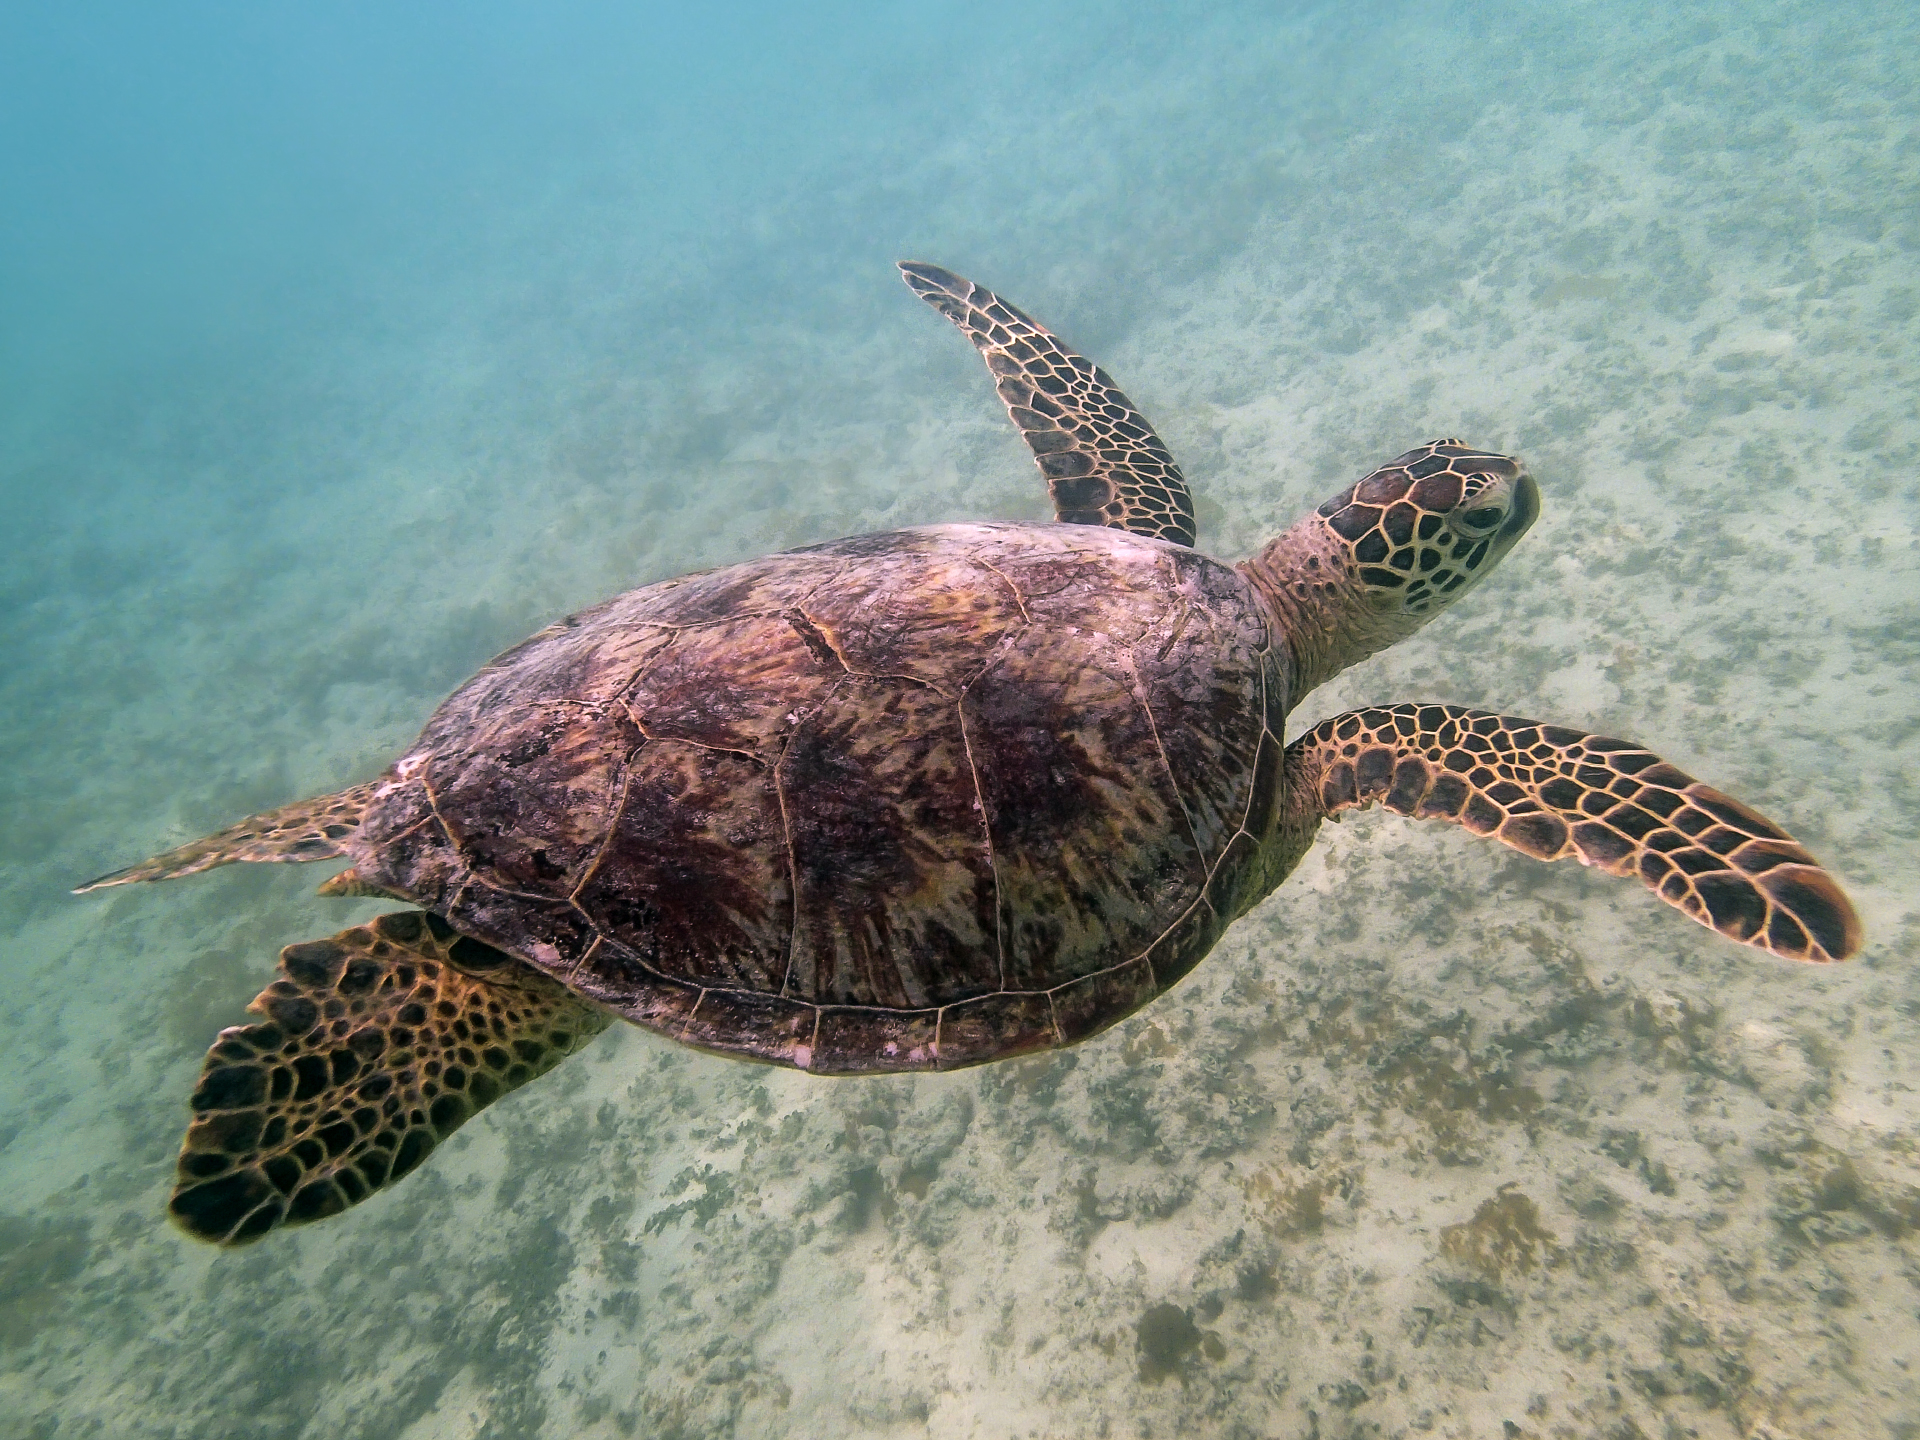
left=167, top=912, right=611, bottom=1244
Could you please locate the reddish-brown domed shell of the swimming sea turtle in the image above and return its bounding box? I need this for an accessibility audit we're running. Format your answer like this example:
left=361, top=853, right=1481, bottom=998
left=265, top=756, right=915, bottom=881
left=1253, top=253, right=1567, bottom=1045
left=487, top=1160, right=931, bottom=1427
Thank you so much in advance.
left=353, top=524, right=1286, bottom=1073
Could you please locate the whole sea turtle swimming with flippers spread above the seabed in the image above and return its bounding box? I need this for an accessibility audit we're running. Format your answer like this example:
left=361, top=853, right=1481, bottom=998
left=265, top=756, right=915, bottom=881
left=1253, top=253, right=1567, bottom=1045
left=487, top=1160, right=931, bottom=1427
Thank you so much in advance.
left=83, top=263, right=1860, bottom=1244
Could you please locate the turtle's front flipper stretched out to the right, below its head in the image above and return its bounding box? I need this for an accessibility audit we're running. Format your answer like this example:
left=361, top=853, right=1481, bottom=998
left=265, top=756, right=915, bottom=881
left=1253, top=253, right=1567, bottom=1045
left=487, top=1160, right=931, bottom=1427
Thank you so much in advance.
left=1286, top=705, right=1860, bottom=960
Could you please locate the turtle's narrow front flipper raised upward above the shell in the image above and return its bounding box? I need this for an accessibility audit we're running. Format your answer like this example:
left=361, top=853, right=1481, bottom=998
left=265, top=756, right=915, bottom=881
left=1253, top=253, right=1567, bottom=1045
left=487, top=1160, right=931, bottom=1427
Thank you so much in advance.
left=900, top=261, right=1196, bottom=545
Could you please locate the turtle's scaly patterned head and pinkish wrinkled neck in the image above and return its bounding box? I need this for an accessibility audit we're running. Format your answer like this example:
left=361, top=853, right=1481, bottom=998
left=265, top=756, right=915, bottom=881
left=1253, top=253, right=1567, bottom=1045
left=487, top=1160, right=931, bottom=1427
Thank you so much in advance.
left=1246, top=440, right=1540, bottom=699
